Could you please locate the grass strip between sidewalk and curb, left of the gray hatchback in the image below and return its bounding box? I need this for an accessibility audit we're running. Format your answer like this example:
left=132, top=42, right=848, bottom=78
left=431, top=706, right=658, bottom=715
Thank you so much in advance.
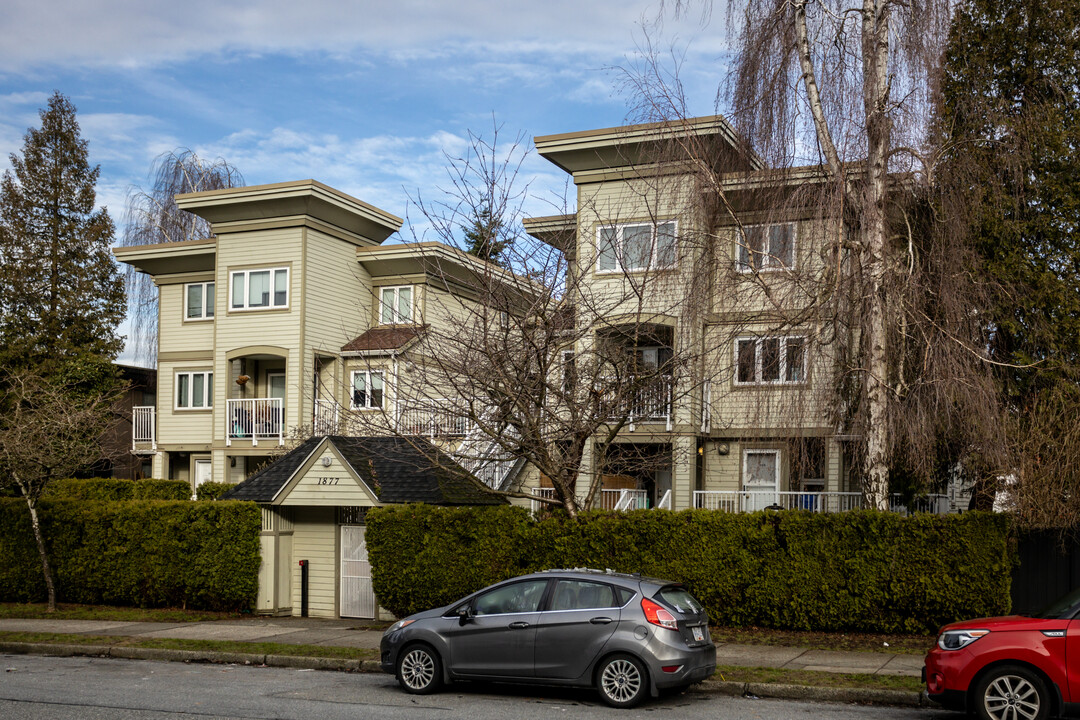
left=0, top=633, right=379, bottom=660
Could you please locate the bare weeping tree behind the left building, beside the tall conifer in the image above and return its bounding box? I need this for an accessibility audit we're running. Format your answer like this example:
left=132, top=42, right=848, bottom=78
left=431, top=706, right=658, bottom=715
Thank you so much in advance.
left=121, top=149, right=244, bottom=365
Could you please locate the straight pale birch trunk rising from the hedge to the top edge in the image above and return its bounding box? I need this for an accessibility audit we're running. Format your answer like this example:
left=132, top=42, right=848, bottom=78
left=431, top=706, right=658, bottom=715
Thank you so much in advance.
left=862, top=0, right=890, bottom=511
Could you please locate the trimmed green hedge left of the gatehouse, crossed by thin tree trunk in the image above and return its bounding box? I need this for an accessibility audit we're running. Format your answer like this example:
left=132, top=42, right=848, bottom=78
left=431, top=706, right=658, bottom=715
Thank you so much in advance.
left=0, top=499, right=260, bottom=610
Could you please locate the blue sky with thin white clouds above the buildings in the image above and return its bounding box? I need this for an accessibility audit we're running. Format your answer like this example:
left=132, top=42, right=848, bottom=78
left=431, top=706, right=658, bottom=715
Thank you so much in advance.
left=0, top=0, right=727, bottom=360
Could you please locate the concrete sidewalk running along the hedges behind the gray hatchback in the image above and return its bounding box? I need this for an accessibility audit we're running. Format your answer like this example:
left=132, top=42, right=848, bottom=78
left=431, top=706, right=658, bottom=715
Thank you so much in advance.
left=0, top=617, right=922, bottom=677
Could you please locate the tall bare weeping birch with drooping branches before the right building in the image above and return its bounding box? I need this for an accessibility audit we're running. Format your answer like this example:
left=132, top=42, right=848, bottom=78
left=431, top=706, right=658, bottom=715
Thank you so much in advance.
left=632, top=0, right=1004, bottom=510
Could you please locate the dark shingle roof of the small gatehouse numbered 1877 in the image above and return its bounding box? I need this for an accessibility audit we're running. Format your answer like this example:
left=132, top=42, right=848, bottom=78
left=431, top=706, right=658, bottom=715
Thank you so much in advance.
left=222, top=435, right=505, bottom=505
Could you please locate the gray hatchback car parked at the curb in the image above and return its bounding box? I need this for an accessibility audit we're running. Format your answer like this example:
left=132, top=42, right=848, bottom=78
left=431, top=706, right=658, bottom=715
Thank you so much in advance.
left=380, top=570, right=716, bottom=707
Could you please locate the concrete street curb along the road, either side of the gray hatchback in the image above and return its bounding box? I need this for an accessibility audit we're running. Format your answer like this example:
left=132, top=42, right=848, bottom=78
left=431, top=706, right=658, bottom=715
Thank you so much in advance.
left=0, top=642, right=933, bottom=707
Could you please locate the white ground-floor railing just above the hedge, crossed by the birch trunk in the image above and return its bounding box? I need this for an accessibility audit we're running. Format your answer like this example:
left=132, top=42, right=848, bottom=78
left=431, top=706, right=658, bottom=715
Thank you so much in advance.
left=693, top=490, right=948, bottom=515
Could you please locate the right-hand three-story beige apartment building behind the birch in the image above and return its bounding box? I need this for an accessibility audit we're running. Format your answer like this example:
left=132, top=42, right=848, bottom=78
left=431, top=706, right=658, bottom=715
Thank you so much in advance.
left=525, top=117, right=862, bottom=511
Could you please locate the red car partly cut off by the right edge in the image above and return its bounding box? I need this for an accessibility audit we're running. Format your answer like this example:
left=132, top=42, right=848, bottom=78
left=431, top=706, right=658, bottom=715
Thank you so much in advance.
left=922, top=588, right=1080, bottom=720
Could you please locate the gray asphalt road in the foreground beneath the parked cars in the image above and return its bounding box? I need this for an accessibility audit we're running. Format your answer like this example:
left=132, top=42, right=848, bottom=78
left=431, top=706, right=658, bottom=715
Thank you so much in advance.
left=0, top=655, right=962, bottom=720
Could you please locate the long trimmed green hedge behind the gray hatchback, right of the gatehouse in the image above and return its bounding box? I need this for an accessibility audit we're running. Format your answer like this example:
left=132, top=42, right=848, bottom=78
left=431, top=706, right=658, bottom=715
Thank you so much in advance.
left=366, top=505, right=1012, bottom=633
